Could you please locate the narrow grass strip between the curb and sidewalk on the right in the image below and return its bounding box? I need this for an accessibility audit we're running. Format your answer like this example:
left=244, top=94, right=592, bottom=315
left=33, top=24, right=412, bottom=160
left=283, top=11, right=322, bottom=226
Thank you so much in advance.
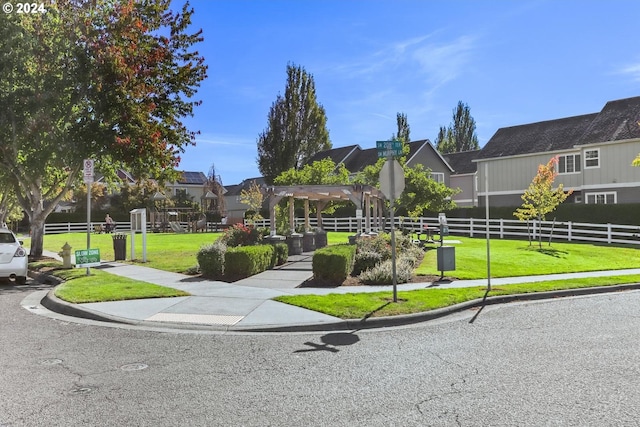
left=274, top=275, right=640, bottom=319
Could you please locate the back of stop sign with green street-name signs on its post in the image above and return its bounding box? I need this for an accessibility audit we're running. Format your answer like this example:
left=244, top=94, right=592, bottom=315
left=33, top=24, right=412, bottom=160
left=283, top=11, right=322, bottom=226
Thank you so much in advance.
left=376, top=141, right=405, bottom=302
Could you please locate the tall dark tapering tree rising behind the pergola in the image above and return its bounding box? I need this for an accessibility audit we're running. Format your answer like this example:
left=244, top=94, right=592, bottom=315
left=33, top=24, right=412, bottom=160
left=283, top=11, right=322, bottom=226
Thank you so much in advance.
left=257, top=64, right=331, bottom=184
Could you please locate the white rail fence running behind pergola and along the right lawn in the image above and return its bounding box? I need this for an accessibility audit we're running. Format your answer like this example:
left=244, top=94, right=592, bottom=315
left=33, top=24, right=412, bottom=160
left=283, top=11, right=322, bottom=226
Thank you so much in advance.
left=249, top=218, right=640, bottom=245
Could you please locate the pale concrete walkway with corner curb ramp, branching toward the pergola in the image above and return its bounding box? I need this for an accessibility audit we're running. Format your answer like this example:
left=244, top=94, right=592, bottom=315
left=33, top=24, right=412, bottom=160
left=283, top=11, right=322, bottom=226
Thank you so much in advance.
left=32, top=253, right=640, bottom=331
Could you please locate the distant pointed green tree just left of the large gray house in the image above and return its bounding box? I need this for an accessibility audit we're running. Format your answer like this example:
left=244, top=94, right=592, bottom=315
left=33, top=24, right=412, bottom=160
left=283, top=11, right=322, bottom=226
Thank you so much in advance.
left=435, top=101, right=480, bottom=154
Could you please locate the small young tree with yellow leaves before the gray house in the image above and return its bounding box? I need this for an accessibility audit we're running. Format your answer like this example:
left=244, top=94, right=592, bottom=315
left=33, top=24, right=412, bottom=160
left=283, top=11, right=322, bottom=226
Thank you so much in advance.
left=513, top=156, right=573, bottom=248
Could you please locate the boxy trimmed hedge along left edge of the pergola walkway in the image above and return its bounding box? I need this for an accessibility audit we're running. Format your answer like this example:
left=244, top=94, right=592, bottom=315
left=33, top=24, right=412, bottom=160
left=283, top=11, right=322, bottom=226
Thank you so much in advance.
left=224, top=245, right=275, bottom=280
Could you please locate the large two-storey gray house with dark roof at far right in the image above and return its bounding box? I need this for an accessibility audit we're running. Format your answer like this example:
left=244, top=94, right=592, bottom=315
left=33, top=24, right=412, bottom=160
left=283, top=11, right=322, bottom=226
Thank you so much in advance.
left=475, top=97, right=640, bottom=206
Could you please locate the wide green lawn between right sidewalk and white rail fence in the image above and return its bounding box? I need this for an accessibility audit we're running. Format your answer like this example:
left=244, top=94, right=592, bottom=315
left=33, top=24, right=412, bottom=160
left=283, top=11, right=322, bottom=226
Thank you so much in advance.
left=416, top=236, right=640, bottom=279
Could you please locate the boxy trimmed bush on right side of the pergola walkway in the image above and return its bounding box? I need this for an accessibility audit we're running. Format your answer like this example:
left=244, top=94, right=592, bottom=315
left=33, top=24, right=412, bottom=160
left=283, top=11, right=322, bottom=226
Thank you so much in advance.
left=312, top=245, right=356, bottom=285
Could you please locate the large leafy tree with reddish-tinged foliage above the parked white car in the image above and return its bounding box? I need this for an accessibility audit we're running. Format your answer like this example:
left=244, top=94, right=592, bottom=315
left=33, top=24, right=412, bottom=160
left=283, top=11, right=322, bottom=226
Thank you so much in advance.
left=0, top=0, right=206, bottom=256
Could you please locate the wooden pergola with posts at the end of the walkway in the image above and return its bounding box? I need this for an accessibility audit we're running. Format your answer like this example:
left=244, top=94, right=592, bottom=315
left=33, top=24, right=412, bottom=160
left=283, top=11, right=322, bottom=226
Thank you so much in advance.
left=266, top=184, right=386, bottom=236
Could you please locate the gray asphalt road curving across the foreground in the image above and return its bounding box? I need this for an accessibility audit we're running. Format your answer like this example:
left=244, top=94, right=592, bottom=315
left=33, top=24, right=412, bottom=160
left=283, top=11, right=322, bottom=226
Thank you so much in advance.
left=0, top=283, right=640, bottom=427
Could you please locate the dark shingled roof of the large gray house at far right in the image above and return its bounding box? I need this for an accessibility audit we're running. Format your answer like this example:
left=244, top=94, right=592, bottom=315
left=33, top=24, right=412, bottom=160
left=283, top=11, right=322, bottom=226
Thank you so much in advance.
left=478, top=97, right=640, bottom=159
